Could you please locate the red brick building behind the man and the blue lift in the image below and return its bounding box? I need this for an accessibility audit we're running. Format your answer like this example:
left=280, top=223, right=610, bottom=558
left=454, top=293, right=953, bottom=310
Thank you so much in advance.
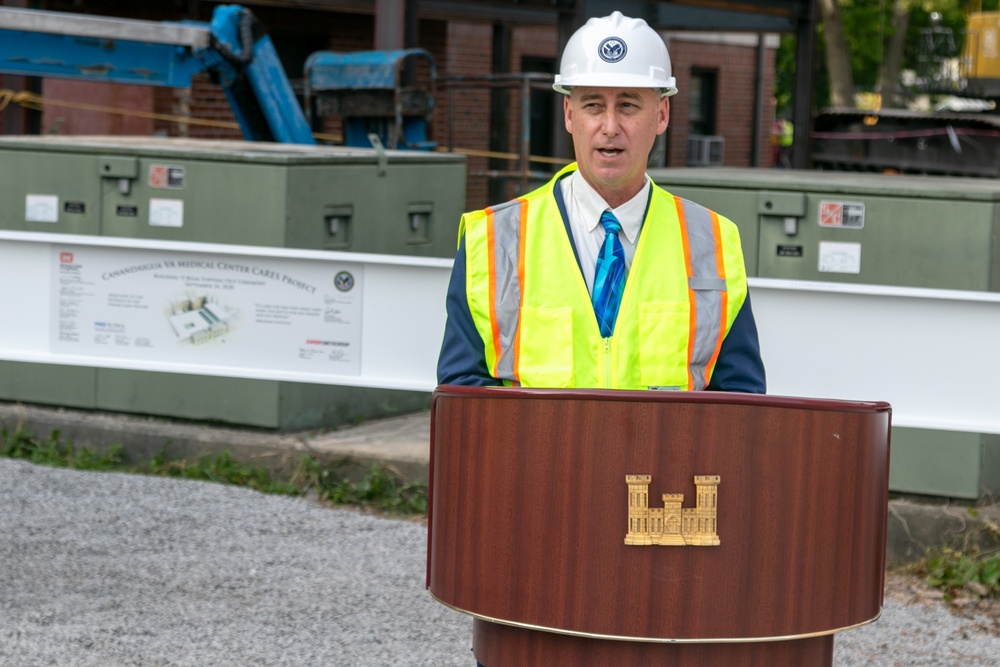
left=0, top=0, right=777, bottom=208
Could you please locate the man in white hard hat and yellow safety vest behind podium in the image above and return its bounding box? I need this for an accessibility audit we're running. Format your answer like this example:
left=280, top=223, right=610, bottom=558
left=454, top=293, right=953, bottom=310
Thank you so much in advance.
left=438, top=12, right=765, bottom=393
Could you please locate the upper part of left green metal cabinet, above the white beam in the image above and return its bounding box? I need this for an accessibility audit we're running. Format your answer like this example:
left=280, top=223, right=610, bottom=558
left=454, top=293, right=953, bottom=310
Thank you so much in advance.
left=0, top=136, right=465, bottom=253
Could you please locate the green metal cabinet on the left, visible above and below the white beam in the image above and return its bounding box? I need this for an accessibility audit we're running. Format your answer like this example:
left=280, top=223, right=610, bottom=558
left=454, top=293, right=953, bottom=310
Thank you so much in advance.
left=0, top=136, right=466, bottom=430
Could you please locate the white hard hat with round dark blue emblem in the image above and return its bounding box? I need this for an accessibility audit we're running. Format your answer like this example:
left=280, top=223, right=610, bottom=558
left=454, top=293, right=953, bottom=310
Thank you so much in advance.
left=552, top=12, right=677, bottom=97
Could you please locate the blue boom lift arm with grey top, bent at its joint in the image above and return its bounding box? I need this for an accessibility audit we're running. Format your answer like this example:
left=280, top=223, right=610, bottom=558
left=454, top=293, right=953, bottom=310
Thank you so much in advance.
left=0, top=5, right=315, bottom=144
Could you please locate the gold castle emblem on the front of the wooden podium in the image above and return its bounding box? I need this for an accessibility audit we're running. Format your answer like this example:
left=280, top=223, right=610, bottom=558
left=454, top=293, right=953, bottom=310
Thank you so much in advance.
left=625, top=475, right=719, bottom=547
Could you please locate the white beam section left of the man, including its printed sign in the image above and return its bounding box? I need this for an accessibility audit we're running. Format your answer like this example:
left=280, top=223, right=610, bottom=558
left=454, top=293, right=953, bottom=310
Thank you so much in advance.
left=0, top=230, right=451, bottom=391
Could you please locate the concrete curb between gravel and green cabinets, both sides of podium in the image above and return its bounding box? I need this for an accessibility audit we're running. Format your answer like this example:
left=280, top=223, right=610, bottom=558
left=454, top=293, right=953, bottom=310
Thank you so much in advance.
left=0, top=403, right=1000, bottom=565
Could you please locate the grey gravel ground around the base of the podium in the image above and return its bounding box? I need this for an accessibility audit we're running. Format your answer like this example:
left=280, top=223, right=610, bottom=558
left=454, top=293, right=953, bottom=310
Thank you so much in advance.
left=0, top=460, right=1000, bottom=667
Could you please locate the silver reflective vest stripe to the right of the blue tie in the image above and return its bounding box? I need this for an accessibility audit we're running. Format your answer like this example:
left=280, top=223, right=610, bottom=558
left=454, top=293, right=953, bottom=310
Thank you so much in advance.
left=679, top=199, right=726, bottom=391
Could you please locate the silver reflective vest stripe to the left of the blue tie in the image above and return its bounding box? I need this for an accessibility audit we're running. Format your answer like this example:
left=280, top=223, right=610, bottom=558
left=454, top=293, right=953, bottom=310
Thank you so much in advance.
left=493, top=200, right=521, bottom=382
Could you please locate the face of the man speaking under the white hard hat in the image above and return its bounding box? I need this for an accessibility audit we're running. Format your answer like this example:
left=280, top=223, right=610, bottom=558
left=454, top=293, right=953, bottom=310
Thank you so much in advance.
left=563, top=87, right=670, bottom=206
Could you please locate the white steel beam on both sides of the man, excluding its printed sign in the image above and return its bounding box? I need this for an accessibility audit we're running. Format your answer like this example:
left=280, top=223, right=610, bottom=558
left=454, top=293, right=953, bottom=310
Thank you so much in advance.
left=0, top=231, right=1000, bottom=433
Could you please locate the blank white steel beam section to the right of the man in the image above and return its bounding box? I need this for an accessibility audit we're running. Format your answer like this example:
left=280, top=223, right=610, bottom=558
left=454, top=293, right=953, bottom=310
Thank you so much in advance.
left=750, top=278, right=1000, bottom=433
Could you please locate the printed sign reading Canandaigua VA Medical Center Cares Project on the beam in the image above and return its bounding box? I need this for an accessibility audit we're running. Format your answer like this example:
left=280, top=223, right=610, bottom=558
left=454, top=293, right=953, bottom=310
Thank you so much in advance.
left=50, top=244, right=363, bottom=375
